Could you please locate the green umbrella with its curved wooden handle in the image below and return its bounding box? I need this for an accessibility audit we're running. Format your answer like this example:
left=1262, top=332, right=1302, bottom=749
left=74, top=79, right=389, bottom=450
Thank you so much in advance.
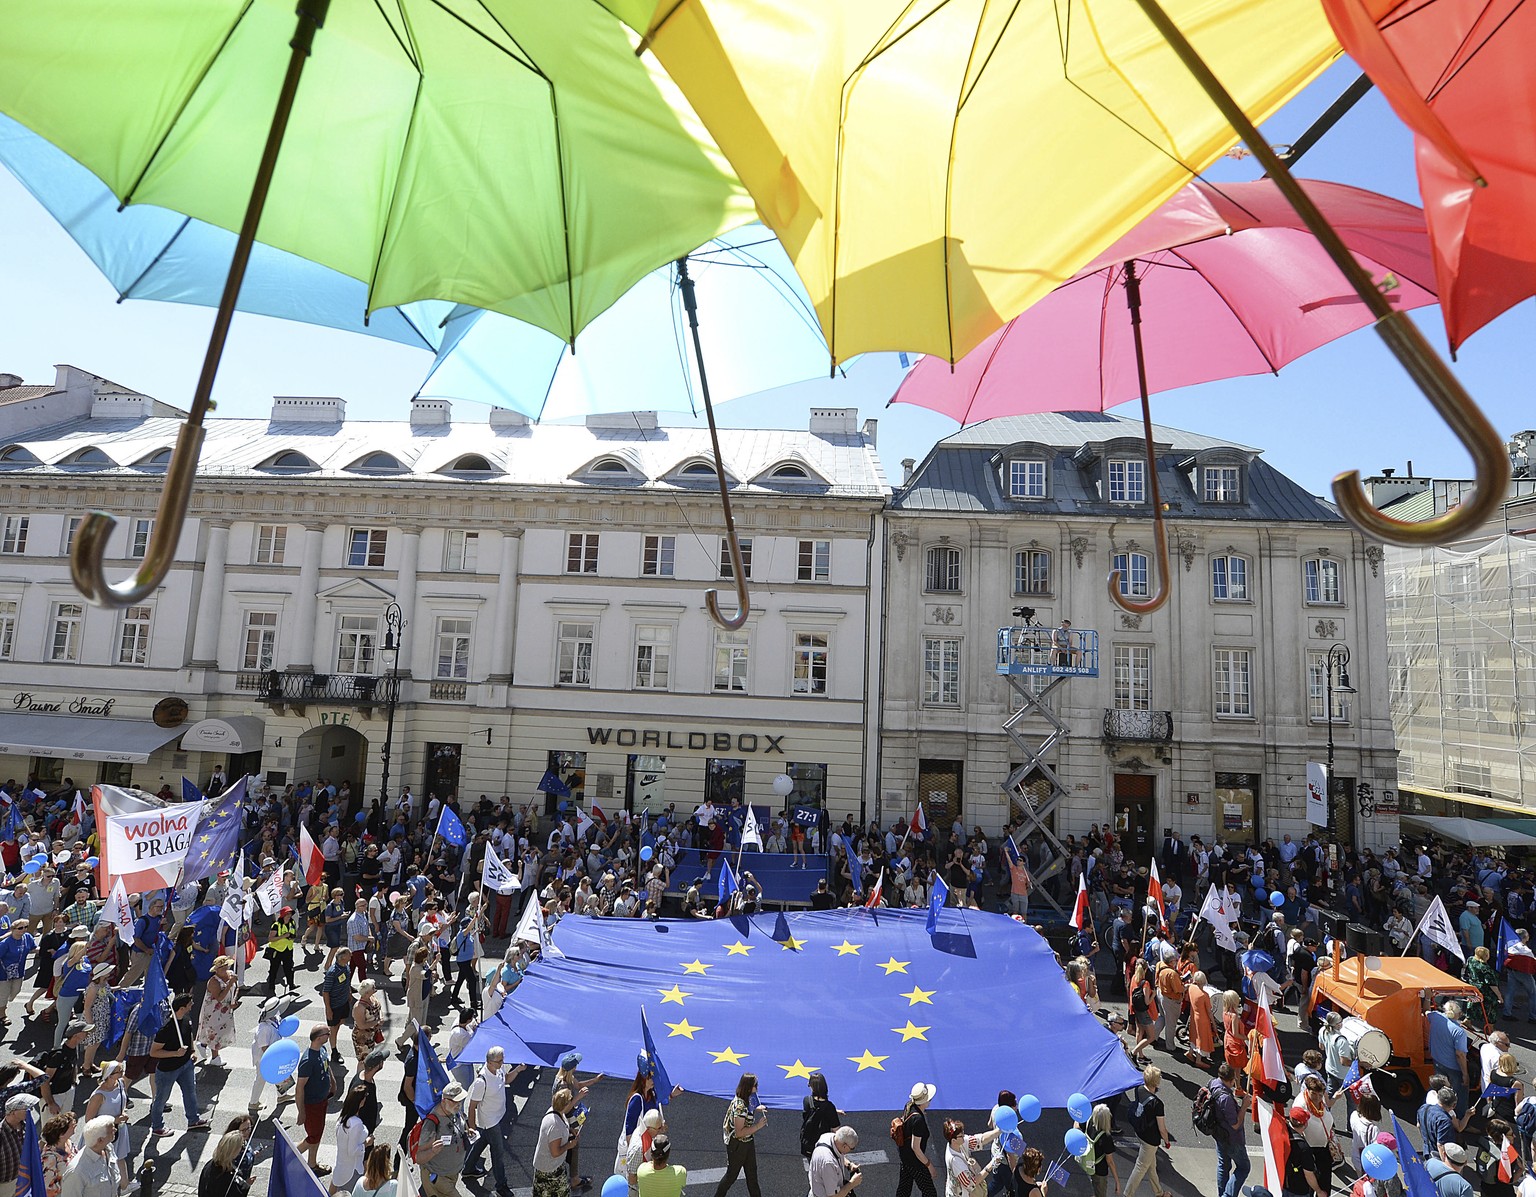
left=0, top=0, right=753, bottom=605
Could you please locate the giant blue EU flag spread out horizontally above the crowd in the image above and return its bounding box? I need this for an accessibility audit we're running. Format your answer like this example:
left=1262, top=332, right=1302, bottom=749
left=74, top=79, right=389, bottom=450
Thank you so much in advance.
left=458, top=908, right=1140, bottom=1109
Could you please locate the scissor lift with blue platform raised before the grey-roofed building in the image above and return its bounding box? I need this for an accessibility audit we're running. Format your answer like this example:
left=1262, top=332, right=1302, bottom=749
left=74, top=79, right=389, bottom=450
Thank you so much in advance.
left=997, top=624, right=1098, bottom=914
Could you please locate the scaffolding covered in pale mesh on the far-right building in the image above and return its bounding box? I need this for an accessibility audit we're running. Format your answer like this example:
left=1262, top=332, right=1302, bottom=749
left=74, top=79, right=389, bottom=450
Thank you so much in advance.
left=1385, top=533, right=1536, bottom=808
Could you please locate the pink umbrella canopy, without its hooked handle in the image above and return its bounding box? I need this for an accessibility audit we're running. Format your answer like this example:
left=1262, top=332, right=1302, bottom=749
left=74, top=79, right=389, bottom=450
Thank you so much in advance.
left=891, top=181, right=1435, bottom=424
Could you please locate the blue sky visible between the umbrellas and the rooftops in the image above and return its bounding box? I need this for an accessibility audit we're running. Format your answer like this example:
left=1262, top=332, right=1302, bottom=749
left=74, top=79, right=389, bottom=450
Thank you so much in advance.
left=0, top=60, right=1536, bottom=493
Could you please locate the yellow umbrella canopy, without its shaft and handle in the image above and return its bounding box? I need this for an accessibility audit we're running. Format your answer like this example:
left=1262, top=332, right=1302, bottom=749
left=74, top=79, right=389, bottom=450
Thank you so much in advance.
left=605, top=0, right=1338, bottom=361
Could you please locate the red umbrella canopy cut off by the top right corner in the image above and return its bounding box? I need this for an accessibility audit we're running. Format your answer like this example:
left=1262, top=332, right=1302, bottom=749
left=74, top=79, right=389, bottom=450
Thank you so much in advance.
left=1322, top=0, right=1536, bottom=349
